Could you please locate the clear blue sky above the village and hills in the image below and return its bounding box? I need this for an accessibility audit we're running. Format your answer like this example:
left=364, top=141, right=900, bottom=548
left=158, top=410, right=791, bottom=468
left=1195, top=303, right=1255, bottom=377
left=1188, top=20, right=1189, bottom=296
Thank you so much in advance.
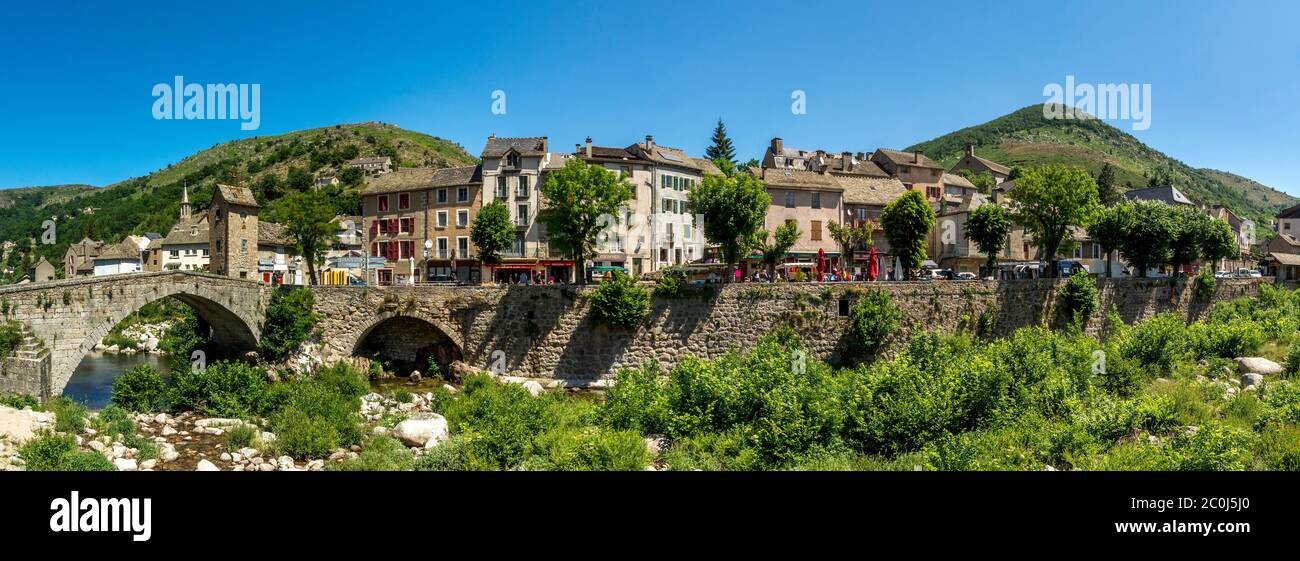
left=0, top=0, right=1300, bottom=195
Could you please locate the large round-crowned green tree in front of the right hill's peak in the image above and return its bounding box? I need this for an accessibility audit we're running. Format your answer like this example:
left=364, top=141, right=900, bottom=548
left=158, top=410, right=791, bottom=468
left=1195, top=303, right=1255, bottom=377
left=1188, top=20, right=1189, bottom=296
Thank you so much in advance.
left=1009, top=165, right=1100, bottom=277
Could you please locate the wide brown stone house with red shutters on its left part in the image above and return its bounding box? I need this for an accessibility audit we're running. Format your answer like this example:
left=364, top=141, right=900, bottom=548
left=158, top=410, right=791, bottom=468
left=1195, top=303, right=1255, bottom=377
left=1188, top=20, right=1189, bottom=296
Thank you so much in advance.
left=361, top=166, right=484, bottom=284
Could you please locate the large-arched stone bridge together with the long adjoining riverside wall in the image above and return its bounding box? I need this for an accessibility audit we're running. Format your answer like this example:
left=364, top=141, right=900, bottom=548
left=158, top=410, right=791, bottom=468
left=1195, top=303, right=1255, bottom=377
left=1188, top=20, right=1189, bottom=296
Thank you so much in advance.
left=0, top=271, right=1273, bottom=396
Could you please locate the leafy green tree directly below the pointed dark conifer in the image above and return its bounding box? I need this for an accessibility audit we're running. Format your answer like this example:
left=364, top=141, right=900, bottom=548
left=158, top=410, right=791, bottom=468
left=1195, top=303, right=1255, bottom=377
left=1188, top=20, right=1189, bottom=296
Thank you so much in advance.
left=690, top=168, right=772, bottom=277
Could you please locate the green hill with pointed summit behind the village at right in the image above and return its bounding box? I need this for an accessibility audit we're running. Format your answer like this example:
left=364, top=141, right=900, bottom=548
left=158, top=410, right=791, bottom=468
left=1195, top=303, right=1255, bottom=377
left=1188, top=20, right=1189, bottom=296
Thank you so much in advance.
left=907, top=105, right=1300, bottom=227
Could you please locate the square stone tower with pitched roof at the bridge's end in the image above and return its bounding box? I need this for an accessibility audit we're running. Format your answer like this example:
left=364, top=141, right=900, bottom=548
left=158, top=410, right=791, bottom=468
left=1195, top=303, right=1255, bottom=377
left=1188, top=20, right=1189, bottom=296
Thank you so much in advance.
left=208, top=184, right=257, bottom=281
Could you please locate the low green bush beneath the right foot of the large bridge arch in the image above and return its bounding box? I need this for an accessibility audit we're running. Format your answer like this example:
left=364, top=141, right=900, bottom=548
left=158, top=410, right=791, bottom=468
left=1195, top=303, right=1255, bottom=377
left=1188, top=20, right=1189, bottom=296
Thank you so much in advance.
left=166, top=361, right=267, bottom=417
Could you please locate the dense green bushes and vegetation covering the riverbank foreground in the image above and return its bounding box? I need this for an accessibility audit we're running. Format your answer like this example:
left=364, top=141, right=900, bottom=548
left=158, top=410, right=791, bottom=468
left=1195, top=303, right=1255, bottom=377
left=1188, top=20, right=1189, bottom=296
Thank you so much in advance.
left=17, top=286, right=1300, bottom=470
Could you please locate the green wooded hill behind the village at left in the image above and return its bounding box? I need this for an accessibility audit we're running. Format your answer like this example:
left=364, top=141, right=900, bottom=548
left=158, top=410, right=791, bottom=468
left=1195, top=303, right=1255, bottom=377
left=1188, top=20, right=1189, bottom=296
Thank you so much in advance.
left=0, top=122, right=477, bottom=282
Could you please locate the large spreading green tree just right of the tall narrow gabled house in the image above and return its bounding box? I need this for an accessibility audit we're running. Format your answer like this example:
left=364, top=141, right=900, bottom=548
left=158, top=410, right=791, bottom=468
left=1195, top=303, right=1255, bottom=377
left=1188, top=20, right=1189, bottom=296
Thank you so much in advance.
left=537, top=158, right=632, bottom=284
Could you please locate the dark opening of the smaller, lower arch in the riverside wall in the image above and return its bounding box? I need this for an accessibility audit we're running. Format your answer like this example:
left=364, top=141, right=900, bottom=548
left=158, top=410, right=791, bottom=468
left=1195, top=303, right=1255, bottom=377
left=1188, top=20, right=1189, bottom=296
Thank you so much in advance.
left=345, top=312, right=464, bottom=375
